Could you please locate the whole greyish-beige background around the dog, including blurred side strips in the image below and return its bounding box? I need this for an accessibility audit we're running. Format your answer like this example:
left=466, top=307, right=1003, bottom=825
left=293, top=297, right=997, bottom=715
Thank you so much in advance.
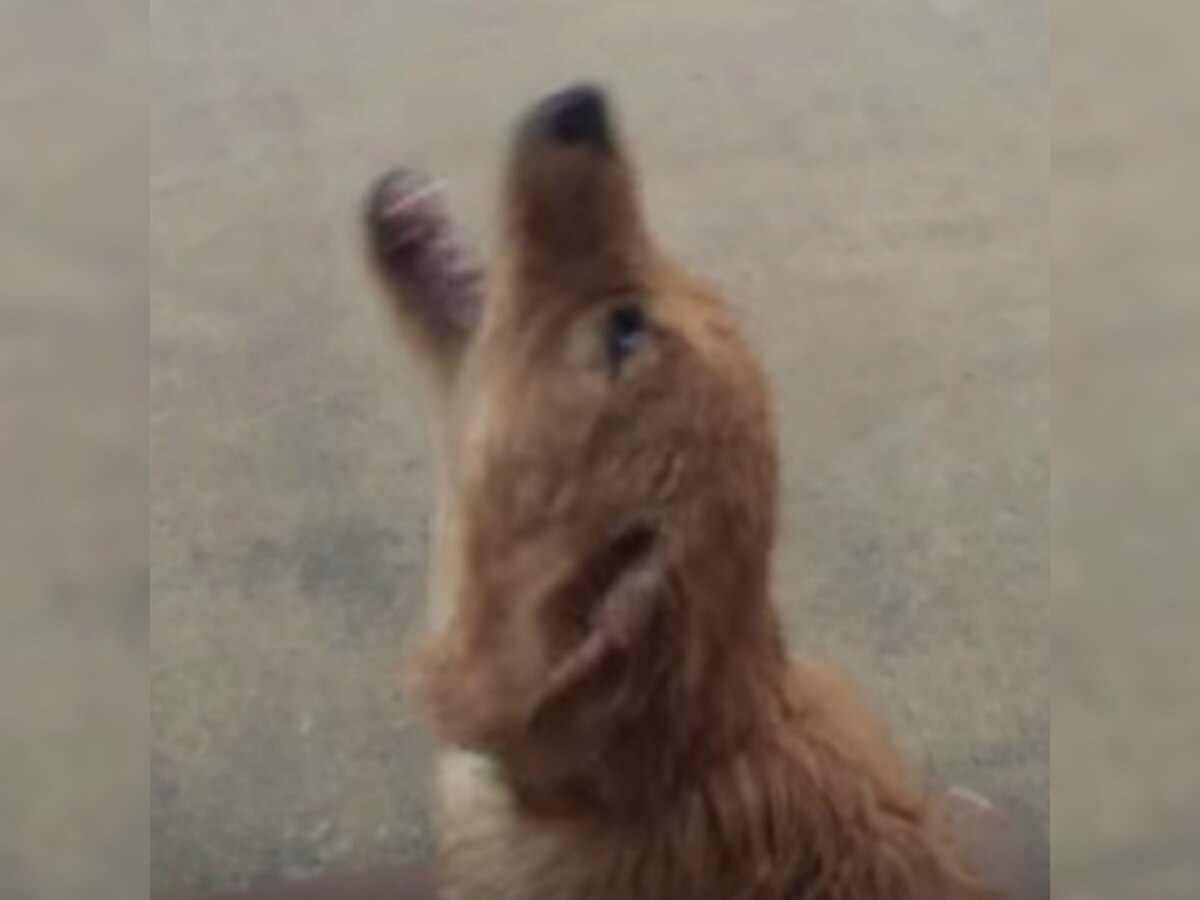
left=9, top=0, right=1200, bottom=900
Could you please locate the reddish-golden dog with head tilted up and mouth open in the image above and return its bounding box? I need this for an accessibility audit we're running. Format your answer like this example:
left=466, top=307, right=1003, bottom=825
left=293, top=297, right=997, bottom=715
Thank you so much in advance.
left=366, top=85, right=992, bottom=900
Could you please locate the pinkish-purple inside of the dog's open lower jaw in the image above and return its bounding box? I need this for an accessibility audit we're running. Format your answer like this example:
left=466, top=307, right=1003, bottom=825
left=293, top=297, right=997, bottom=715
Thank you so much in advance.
left=367, top=169, right=482, bottom=332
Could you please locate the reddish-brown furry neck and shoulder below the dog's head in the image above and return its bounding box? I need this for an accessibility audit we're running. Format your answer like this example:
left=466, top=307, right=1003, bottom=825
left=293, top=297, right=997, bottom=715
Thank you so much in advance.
left=477, top=607, right=983, bottom=900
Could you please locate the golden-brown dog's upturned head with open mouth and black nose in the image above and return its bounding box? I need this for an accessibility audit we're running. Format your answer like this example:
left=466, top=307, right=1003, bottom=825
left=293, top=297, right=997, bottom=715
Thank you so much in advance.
left=367, top=86, right=784, bottom=816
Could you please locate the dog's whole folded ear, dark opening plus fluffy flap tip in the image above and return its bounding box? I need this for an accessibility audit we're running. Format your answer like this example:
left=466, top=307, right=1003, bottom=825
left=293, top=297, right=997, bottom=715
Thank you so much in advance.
left=408, top=524, right=670, bottom=770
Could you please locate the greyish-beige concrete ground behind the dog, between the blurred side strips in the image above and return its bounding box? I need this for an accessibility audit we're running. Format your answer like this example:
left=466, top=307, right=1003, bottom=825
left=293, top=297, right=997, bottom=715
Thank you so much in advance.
left=150, top=0, right=1050, bottom=895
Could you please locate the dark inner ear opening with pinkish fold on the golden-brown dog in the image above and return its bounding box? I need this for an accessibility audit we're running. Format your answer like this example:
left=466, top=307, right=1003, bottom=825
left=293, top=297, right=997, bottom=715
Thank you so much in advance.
left=530, top=524, right=667, bottom=721
